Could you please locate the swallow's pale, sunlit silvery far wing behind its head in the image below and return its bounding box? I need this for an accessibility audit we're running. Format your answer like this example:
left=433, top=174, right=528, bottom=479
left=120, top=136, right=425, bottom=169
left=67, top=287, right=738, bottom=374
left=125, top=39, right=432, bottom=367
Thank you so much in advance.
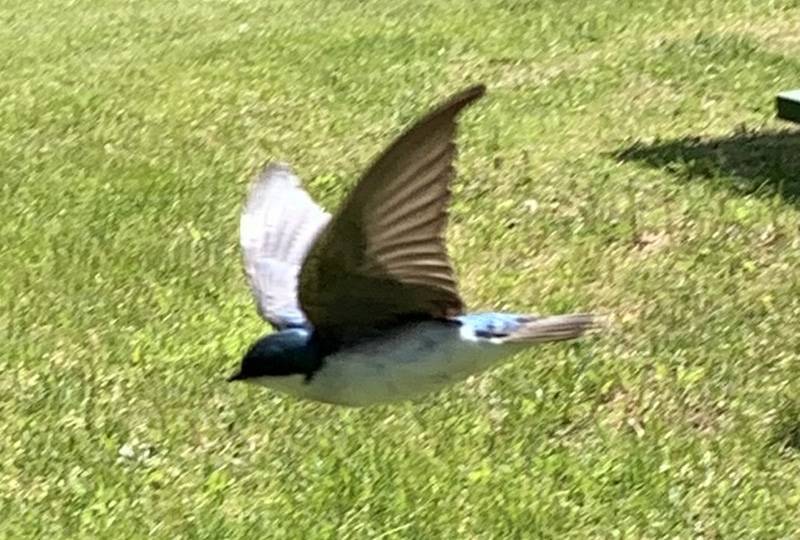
left=239, top=164, right=330, bottom=329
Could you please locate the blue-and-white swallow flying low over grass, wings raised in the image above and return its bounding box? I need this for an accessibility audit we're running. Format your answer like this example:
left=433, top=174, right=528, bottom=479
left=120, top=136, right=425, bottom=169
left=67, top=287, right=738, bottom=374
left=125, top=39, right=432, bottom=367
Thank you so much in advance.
left=229, top=85, right=595, bottom=406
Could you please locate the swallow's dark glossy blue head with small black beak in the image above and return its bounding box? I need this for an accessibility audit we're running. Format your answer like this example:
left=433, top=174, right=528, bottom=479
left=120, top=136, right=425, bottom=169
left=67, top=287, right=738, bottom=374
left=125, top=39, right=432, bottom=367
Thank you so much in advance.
left=228, top=329, right=321, bottom=382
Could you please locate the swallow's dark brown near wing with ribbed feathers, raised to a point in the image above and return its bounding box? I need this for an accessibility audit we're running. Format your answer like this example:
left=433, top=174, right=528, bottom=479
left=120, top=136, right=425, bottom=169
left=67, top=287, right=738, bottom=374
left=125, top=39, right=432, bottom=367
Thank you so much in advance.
left=299, top=85, right=485, bottom=342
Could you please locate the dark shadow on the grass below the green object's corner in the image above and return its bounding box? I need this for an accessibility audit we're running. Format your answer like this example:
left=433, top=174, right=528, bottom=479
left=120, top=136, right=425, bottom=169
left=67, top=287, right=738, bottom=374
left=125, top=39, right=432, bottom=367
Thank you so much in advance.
left=613, top=129, right=800, bottom=204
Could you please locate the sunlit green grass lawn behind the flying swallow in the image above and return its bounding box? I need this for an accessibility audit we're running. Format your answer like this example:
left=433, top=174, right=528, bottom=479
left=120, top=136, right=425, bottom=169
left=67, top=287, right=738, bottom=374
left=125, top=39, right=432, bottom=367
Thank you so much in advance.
left=0, top=0, right=800, bottom=539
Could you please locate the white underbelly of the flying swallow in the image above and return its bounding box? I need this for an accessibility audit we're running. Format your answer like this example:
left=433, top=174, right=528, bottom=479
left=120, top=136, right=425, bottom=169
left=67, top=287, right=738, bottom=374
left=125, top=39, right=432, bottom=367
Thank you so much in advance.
left=284, top=322, right=516, bottom=406
